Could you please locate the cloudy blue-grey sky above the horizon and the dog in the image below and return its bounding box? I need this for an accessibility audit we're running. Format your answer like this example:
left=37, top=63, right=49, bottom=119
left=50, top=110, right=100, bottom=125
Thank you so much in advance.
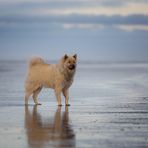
left=0, top=0, right=148, bottom=61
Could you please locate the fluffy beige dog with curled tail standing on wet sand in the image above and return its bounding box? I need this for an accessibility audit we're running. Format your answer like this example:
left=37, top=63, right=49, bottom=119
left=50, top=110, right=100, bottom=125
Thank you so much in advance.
left=25, top=54, right=77, bottom=106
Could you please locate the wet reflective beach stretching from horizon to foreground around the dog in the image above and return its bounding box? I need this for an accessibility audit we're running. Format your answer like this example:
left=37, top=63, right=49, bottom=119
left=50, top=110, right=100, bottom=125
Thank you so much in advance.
left=0, top=61, right=148, bottom=148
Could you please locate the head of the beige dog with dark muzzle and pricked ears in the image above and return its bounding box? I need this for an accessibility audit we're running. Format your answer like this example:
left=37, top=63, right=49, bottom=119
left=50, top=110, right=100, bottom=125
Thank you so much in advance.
left=63, top=54, right=77, bottom=72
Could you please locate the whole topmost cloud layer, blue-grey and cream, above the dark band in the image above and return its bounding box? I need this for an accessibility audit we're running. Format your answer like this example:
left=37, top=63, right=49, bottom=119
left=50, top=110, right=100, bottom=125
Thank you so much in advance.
left=0, top=0, right=148, bottom=16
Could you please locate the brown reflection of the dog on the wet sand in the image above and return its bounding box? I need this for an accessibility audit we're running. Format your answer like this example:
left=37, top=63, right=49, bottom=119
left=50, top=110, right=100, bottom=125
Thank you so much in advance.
left=25, top=105, right=75, bottom=148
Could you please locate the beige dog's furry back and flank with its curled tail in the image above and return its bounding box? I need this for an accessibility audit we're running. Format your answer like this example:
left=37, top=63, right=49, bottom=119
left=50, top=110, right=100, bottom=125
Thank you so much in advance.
left=25, top=58, right=59, bottom=92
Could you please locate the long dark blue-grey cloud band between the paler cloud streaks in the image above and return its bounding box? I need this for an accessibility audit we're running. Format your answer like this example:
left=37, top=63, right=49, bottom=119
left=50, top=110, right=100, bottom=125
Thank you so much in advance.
left=0, top=15, right=148, bottom=25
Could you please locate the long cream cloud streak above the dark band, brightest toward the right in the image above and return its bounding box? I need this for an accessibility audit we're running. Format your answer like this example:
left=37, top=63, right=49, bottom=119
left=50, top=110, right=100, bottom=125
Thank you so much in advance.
left=17, top=3, right=148, bottom=16
